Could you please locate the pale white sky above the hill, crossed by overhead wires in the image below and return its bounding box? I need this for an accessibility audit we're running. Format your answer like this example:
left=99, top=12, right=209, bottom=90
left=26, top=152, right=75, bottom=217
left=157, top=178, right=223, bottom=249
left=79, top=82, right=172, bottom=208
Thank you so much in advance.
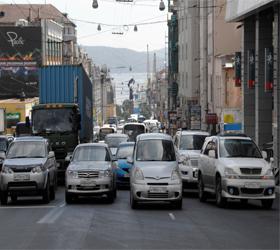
left=0, top=0, right=167, bottom=51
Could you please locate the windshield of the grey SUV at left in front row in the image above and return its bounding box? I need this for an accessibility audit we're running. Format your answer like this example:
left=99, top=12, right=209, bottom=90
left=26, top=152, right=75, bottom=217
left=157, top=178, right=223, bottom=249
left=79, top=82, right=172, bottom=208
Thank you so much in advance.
left=7, top=141, right=46, bottom=159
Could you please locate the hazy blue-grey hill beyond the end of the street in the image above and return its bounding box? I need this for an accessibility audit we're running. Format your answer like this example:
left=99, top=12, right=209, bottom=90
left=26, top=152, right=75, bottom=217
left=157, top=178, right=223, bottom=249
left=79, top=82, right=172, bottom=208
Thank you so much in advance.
left=83, top=46, right=165, bottom=73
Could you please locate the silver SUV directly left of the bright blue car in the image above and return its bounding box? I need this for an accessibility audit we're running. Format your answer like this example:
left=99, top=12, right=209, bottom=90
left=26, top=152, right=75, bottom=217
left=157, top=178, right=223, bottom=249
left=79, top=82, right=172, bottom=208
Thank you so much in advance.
left=65, top=143, right=117, bottom=203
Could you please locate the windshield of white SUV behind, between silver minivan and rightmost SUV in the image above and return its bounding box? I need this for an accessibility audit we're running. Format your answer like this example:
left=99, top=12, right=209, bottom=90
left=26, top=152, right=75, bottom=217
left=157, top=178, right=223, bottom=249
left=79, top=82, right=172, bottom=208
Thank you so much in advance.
left=179, top=135, right=207, bottom=150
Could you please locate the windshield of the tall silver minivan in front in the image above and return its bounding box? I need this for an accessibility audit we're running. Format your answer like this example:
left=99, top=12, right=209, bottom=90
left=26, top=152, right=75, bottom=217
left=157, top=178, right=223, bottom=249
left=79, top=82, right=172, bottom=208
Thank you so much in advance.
left=136, top=139, right=176, bottom=161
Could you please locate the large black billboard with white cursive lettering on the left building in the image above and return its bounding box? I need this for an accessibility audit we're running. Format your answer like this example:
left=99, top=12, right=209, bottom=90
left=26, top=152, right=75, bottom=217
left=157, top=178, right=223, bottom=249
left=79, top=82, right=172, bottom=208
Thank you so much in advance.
left=0, top=26, right=42, bottom=99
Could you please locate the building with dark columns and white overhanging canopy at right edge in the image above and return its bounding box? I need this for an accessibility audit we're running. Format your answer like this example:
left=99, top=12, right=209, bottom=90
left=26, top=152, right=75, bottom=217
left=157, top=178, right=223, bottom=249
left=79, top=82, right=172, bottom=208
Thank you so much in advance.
left=226, top=0, right=280, bottom=183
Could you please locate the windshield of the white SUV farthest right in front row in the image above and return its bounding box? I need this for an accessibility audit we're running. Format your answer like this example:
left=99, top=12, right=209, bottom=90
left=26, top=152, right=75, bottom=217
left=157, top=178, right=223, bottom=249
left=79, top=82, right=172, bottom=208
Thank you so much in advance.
left=220, top=139, right=262, bottom=158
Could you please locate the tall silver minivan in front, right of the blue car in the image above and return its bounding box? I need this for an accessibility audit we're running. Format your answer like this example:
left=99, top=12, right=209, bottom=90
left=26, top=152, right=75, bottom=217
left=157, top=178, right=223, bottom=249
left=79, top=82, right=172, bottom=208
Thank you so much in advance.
left=128, top=133, right=182, bottom=209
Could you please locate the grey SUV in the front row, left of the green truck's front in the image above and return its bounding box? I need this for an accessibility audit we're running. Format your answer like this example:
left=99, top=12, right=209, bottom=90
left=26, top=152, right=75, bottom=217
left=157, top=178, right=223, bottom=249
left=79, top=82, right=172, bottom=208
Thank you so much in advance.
left=0, top=136, right=57, bottom=205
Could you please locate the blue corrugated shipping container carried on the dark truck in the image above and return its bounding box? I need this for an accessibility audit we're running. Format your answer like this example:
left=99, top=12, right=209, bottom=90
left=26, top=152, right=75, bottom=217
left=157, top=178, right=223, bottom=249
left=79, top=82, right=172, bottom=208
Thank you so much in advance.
left=39, top=65, right=93, bottom=142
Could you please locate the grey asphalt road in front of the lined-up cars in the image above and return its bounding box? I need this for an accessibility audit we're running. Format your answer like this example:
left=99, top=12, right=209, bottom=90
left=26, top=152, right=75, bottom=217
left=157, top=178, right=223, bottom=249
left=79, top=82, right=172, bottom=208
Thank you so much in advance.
left=0, top=187, right=279, bottom=249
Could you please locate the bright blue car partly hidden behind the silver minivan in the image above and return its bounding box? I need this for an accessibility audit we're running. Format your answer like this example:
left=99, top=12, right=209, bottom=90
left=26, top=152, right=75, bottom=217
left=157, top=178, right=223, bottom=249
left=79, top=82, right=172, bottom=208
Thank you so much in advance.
left=116, top=142, right=135, bottom=187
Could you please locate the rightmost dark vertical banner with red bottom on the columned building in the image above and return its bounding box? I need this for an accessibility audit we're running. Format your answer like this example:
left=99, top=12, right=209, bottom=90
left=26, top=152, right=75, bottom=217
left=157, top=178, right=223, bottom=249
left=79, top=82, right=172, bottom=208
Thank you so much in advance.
left=264, top=48, right=273, bottom=92
